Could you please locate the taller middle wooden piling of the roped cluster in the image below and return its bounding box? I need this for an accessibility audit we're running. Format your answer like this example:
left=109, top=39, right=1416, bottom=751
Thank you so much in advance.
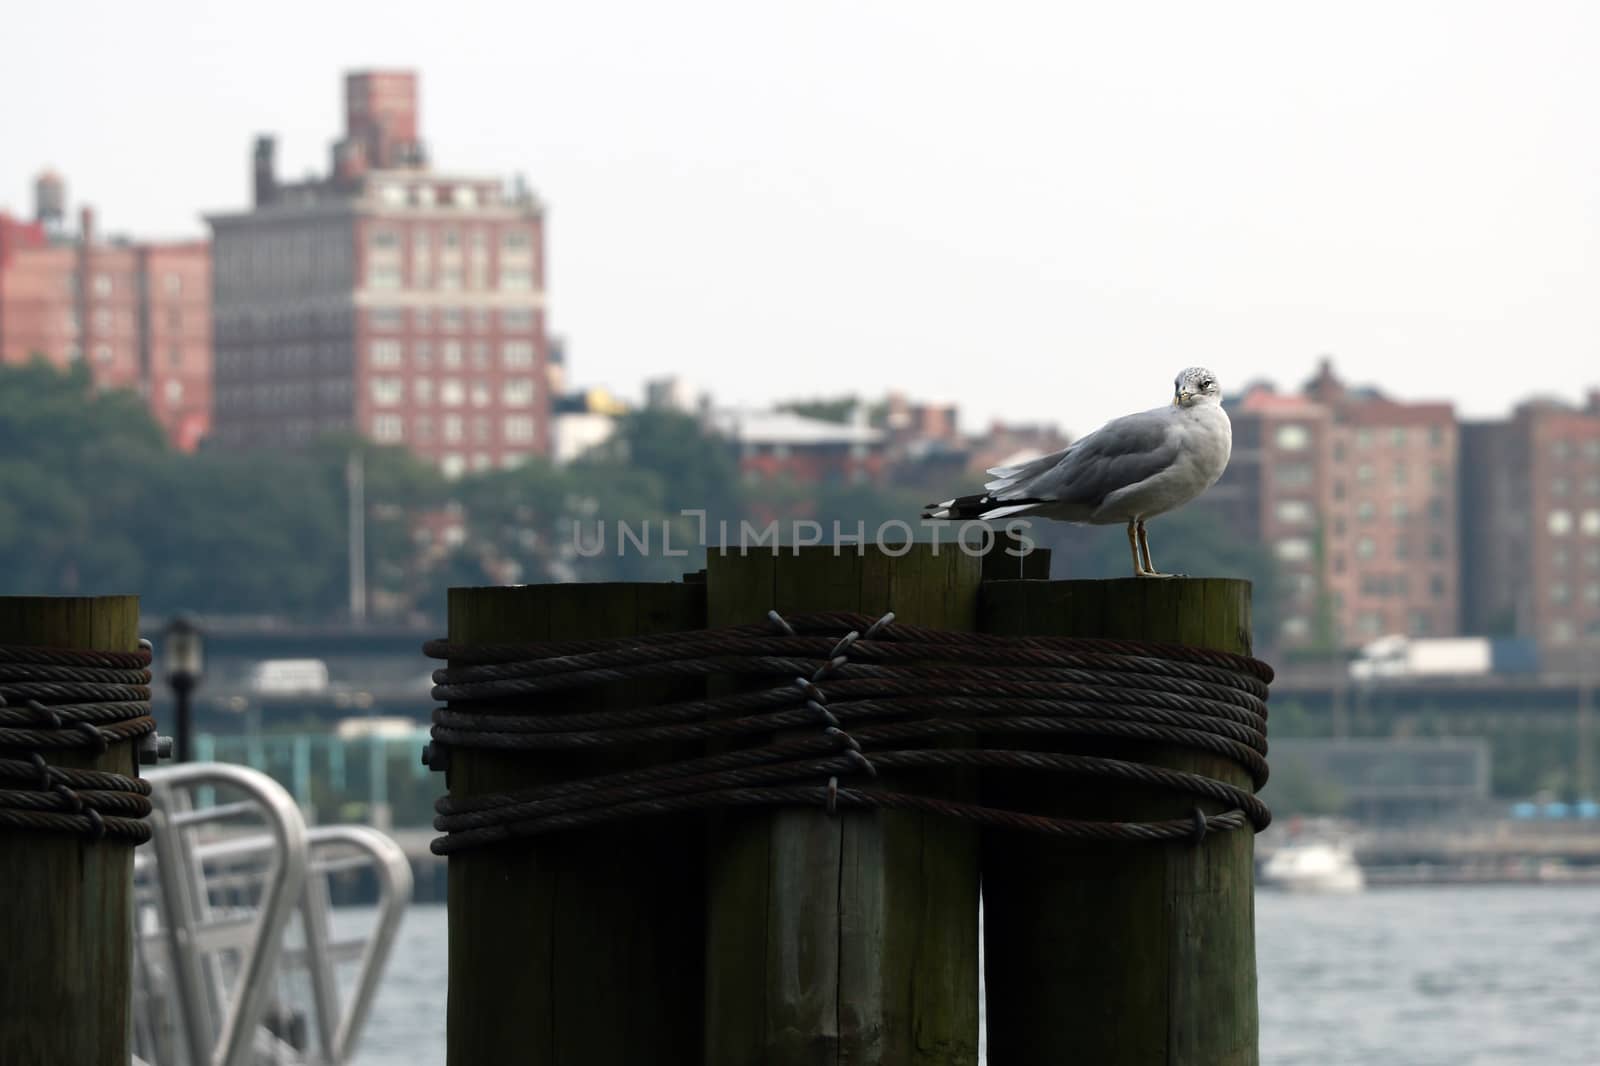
left=706, top=544, right=981, bottom=1066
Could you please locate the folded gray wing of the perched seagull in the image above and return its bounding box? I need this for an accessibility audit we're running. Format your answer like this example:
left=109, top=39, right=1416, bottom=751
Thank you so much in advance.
left=995, top=407, right=1178, bottom=511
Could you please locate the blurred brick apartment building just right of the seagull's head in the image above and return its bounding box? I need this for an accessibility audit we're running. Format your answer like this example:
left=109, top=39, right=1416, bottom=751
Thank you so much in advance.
left=1200, top=360, right=1461, bottom=648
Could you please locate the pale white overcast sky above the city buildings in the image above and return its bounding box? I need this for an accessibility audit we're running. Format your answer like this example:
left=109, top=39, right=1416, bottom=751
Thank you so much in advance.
left=0, top=0, right=1600, bottom=432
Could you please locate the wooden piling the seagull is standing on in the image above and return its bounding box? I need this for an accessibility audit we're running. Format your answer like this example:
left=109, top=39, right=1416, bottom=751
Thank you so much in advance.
left=981, top=578, right=1258, bottom=1066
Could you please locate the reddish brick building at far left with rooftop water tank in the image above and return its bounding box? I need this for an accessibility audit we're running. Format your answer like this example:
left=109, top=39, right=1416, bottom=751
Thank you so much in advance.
left=0, top=173, right=211, bottom=451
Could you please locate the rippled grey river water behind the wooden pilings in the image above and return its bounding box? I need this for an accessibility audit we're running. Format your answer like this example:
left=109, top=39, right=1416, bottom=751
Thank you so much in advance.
left=347, top=885, right=1600, bottom=1066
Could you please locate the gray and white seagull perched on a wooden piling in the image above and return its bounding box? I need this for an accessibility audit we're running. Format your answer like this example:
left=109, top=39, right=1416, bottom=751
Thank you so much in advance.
left=922, top=367, right=1234, bottom=578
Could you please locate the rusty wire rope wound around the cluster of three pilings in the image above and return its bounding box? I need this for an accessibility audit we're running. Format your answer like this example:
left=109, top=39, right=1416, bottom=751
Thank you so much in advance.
left=424, top=611, right=1272, bottom=855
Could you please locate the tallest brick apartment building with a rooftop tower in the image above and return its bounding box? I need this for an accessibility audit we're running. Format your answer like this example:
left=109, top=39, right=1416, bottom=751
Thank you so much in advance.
left=208, top=72, right=550, bottom=475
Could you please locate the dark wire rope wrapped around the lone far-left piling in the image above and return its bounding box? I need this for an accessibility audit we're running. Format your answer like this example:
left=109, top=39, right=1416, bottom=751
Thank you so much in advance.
left=0, top=642, right=155, bottom=844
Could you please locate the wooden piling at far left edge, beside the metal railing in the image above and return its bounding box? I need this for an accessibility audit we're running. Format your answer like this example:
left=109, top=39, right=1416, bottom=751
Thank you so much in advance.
left=0, top=595, right=139, bottom=1066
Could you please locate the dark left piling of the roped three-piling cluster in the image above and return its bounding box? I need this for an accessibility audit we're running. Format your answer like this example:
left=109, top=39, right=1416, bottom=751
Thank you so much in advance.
left=446, top=583, right=706, bottom=1066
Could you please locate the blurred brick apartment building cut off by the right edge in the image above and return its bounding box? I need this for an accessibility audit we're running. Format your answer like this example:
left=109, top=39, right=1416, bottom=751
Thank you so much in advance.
left=1461, top=391, right=1600, bottom=666
